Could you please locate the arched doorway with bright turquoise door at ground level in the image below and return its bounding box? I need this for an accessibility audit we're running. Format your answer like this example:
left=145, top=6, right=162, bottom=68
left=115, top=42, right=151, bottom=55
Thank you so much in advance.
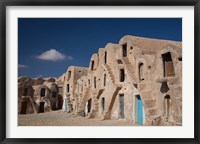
left=135, top=95, right=143, bottom=125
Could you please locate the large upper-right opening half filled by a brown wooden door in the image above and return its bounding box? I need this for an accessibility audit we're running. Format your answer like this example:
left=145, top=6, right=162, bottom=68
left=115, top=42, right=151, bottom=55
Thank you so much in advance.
left=162, top=52, right=175, bottom=77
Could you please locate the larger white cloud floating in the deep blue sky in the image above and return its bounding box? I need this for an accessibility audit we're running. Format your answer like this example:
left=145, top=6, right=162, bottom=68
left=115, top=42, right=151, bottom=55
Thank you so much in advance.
left=36, top=49, right=73, bottom=61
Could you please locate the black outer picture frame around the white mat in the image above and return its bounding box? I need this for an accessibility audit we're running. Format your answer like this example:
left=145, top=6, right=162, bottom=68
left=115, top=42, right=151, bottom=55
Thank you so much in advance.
left=0, top=0, right=200, bottom=144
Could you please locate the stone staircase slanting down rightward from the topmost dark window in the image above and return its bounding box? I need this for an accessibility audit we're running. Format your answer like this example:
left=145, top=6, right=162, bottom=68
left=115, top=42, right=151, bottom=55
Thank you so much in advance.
left=122, top=57, right=137, bottom=84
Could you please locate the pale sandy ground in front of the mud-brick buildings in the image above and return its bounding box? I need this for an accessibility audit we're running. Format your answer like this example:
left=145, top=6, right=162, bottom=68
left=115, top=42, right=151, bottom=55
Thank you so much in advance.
left=18, top=110, right=133, bottom=126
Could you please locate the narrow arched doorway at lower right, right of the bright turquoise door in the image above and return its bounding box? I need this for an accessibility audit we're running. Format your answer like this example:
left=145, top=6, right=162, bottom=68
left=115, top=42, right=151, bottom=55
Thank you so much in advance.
left=164, top=95, right=171, bottom=121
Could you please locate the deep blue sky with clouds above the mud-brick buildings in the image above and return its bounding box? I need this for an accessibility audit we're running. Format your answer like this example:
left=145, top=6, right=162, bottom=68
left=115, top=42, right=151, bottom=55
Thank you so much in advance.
left=18, top=18, right=182, bottom=78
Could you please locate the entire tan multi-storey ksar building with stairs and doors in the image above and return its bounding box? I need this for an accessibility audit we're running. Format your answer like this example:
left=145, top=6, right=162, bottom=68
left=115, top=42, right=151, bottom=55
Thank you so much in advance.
left=19, top=36, right=182, bottom=125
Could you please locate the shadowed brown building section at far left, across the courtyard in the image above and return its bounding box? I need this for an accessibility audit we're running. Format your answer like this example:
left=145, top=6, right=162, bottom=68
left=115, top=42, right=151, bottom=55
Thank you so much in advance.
left=18, top=77, right=63, bottom=114
